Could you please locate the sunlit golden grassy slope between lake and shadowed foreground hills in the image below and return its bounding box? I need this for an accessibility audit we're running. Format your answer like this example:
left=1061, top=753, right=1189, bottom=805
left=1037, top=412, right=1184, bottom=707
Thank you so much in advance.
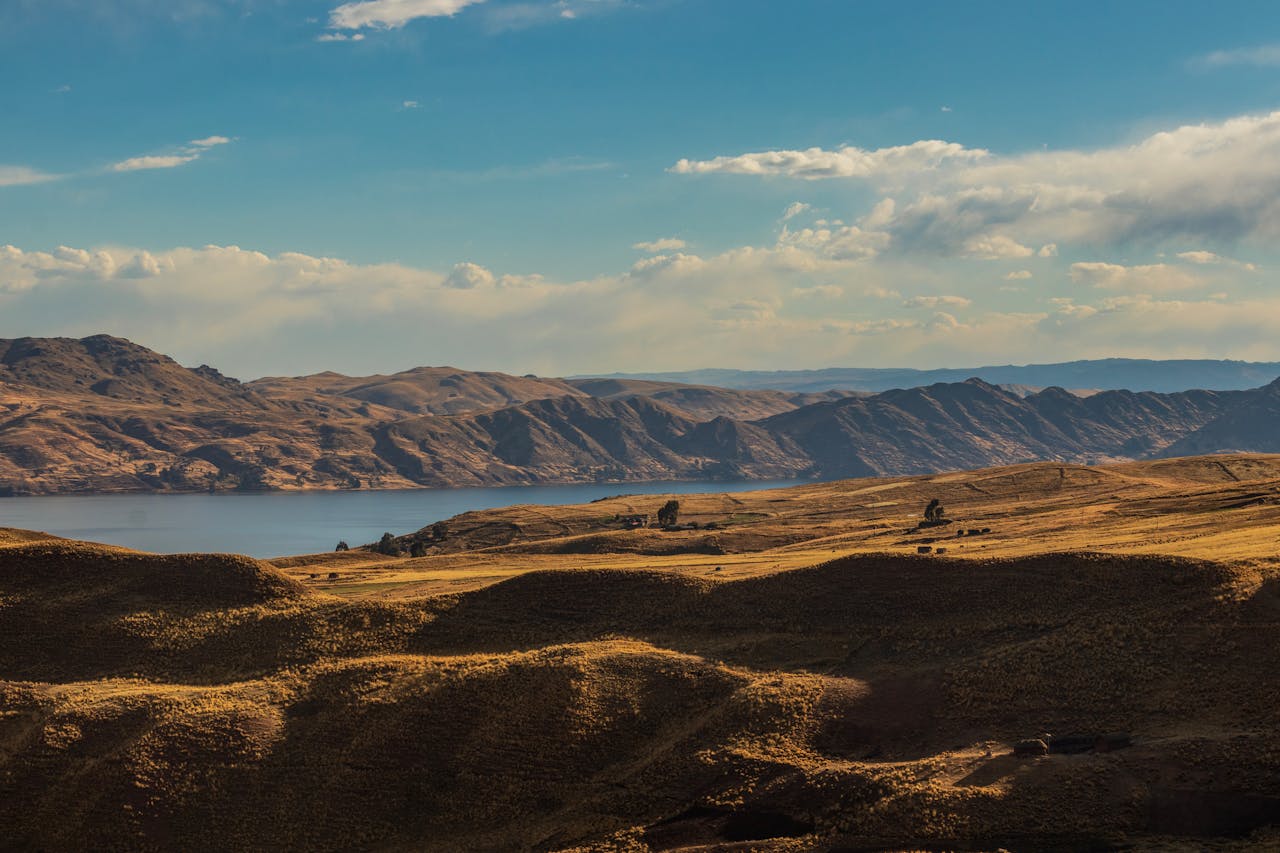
left=278, top=455, right=1280, bottom=596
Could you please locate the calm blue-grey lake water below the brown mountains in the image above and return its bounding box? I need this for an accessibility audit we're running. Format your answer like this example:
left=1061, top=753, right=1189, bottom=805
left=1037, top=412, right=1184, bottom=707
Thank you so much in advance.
left=0, top=480, right=808, bottom=557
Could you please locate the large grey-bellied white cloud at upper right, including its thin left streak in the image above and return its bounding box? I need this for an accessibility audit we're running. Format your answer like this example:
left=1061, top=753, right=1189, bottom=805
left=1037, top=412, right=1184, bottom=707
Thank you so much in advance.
left=672, top=111, right=1280, bottom=257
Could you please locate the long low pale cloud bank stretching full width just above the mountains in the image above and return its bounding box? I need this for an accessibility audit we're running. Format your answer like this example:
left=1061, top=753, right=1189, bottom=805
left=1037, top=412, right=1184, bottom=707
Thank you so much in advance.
left=0, top=230, right=1280, bottom=378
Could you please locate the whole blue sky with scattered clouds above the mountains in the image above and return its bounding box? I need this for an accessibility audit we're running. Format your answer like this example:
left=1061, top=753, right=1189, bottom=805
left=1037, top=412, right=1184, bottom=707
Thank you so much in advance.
left=0, top=0, right=1280, bottom=379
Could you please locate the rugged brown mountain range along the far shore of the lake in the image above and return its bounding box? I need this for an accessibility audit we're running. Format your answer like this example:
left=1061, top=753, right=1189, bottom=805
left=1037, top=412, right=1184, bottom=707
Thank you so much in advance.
left=0, top=336, right=1280, bottom=494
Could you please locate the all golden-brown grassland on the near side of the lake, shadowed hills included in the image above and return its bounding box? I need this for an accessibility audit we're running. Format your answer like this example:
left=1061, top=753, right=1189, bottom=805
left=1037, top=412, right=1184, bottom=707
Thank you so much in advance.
left=0, top=455, right=1280, bottom=852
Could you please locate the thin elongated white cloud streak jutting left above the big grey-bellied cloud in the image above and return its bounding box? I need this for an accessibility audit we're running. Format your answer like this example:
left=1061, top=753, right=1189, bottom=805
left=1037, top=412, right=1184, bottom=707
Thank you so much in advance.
left=671, top=140, right=987, bottom=181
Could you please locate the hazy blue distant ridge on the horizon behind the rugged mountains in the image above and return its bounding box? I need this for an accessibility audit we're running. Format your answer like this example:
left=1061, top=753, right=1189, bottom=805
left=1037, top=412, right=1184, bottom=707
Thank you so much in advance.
left=583, top=359, right=1280, bottom=393
